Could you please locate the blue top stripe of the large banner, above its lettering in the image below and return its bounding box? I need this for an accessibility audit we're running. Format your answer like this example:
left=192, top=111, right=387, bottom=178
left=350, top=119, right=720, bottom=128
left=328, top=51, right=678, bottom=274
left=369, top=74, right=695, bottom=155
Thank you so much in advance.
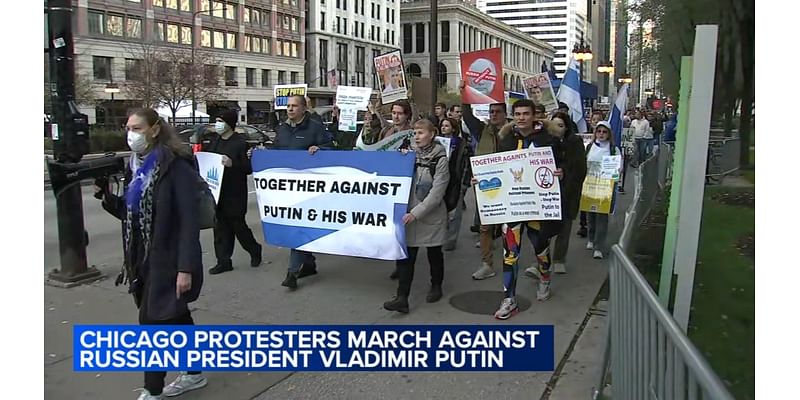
left=252, top=149, right=416, bottom=176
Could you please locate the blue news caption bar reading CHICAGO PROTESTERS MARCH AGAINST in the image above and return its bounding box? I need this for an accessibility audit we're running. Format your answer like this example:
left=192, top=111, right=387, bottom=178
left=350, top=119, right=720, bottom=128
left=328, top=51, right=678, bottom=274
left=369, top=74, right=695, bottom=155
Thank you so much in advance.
left=73, top=325, right=555, bottom=372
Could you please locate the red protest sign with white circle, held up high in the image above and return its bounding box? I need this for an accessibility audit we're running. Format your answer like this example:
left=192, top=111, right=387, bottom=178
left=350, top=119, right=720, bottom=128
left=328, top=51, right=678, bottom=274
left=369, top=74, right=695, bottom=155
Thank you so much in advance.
left=461, top=47, right=505, bottom=104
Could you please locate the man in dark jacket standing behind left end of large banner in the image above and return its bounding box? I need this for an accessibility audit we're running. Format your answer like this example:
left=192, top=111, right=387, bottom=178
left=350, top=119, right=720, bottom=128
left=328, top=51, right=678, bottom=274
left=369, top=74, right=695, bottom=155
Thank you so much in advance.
left=274, top=96, right=332, bottom=289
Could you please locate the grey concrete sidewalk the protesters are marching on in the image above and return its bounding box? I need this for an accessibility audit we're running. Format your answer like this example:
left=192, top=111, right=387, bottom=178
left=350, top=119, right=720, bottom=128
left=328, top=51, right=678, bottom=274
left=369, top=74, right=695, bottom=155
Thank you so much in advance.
left=44, top=188, right=631, bottom=400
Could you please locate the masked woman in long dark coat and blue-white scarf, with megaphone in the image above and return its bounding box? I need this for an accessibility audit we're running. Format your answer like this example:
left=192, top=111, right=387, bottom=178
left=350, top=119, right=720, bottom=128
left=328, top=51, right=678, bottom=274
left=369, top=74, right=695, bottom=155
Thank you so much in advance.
left=95, top=109, right=207, bottom=400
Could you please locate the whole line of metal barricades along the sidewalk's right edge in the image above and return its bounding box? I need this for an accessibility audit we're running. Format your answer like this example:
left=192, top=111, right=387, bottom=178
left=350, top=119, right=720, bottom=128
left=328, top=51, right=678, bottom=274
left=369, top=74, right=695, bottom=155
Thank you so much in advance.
left=592, top=144, right=733, bottom=400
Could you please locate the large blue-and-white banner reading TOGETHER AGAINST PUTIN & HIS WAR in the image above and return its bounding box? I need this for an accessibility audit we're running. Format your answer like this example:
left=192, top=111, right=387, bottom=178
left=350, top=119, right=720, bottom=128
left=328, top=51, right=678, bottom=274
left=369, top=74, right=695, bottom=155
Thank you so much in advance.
left=252, top=150, right=415, bottom=260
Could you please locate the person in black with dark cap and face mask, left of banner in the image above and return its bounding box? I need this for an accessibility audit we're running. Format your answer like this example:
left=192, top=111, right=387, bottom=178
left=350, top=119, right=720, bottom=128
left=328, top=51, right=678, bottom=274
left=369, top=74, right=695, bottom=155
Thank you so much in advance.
left=203, top=110, right=261, bottom=275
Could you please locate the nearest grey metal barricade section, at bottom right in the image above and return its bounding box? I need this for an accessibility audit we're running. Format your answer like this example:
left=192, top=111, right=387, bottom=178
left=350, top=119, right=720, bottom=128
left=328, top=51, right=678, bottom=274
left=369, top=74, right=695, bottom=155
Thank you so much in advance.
left=609, top=245, right=733, bottom=400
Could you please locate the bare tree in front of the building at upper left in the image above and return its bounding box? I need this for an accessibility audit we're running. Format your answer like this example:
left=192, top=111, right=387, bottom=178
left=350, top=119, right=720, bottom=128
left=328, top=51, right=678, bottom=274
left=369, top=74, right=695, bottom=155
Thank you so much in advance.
left=125, top=43, right=225, bottom=118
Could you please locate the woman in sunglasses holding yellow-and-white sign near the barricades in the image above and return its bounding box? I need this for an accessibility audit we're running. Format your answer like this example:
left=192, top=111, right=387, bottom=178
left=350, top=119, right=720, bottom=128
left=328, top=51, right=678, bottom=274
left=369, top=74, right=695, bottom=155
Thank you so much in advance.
left=586, top=121, right=622, bottom=259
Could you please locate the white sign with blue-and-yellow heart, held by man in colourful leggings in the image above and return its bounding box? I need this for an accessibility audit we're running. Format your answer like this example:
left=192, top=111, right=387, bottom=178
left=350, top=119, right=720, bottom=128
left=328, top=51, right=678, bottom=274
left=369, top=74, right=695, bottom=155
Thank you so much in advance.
left=470, top=147, right=561, bottom=225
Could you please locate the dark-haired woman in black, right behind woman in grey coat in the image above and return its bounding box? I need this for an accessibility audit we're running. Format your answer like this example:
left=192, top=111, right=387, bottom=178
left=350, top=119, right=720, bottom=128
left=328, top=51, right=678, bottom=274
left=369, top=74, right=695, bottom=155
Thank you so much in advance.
left=439, top=118, right=471, bottom=251
